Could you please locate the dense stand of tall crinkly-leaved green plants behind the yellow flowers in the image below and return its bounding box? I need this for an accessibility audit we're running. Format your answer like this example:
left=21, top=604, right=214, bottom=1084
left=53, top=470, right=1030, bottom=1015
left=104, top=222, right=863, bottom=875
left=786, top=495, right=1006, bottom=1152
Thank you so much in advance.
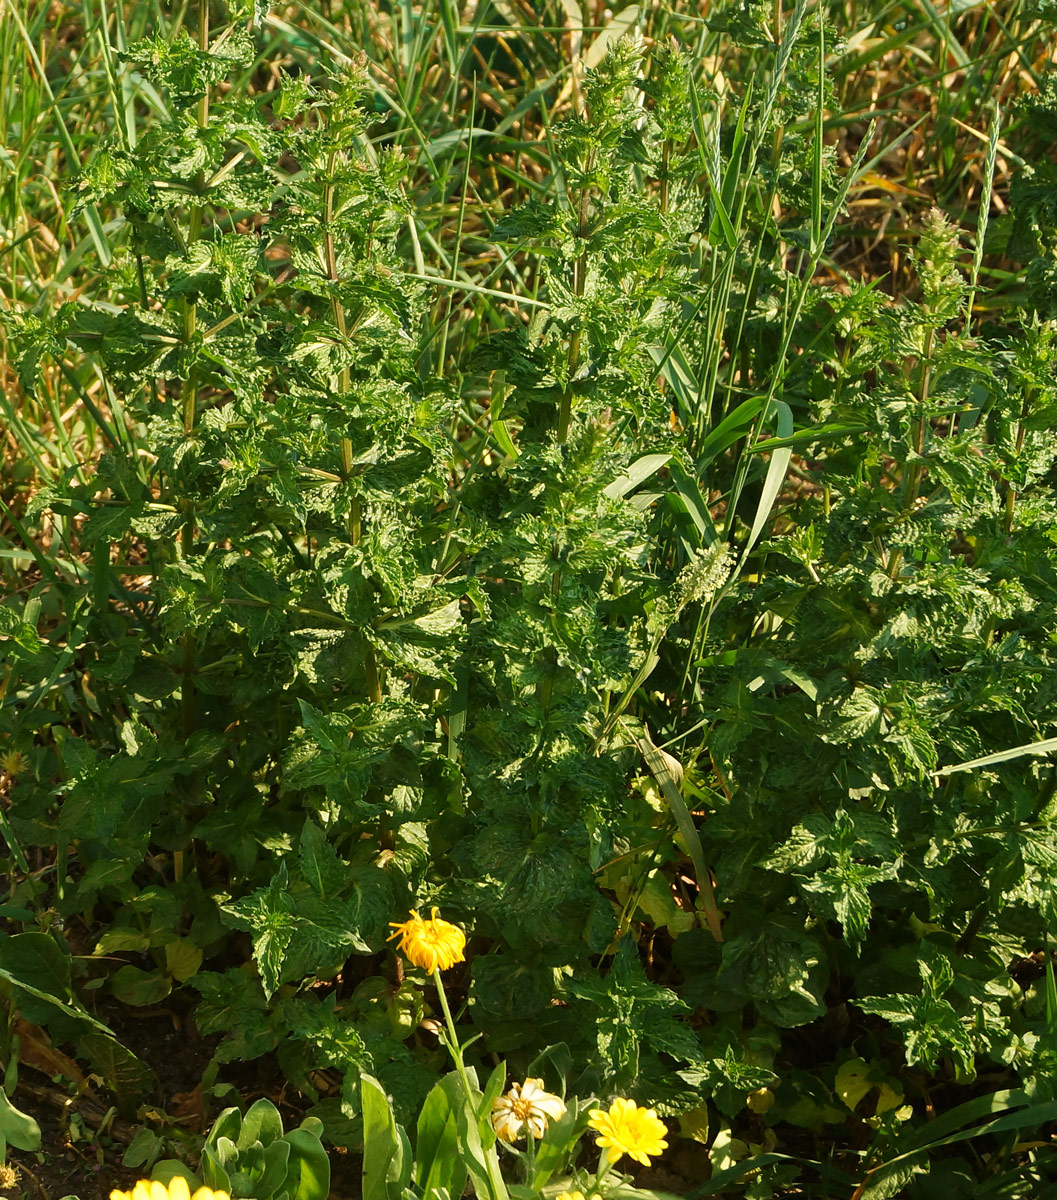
left=0, top=0, right=1057, bottom=1200
